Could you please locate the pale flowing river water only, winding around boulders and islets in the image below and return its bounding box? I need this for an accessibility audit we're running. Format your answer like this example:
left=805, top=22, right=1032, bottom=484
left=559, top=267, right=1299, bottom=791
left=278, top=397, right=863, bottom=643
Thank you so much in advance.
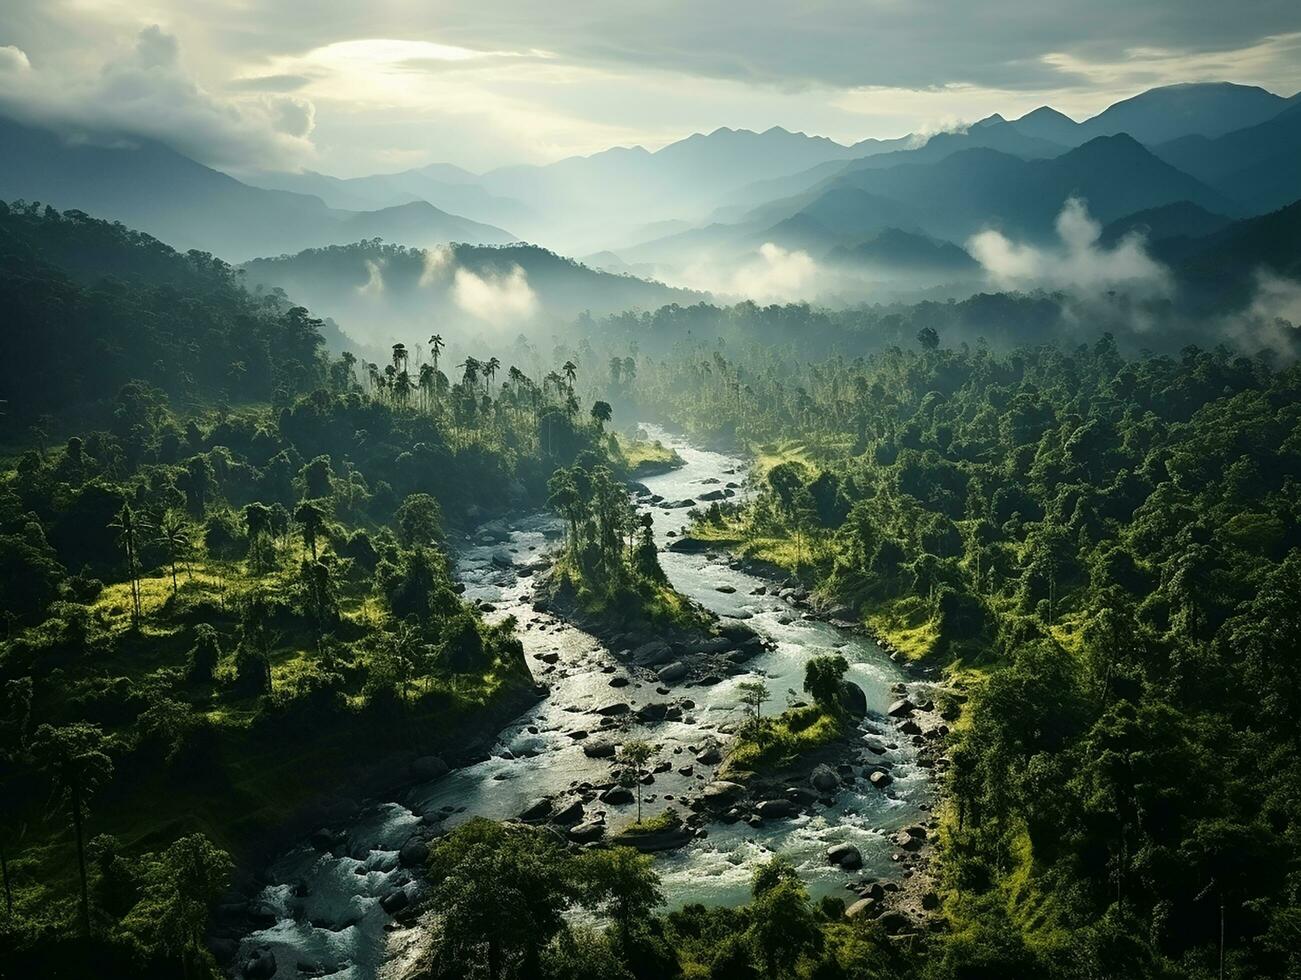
left=228, top=426, right=933, bottom=980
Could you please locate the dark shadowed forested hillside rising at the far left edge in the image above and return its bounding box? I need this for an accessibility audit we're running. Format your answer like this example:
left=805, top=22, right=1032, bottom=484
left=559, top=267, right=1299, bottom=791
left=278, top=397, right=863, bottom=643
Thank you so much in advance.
left=0, top=202, right=324, bottom=426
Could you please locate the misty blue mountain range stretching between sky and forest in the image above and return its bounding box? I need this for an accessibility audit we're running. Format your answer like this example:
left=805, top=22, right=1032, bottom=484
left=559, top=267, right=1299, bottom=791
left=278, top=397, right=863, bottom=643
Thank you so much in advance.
left=0, top=83, right=1301, bottom=305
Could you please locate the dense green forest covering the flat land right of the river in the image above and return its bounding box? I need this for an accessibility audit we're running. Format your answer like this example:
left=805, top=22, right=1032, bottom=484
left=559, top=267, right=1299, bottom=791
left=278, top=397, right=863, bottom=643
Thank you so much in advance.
left=588, top=328, right=1301, bottom=976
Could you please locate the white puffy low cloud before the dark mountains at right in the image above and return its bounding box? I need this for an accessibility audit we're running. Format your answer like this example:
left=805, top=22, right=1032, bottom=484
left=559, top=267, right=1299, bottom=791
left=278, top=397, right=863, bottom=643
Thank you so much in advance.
left=967, top=198, right=1171, bottom=295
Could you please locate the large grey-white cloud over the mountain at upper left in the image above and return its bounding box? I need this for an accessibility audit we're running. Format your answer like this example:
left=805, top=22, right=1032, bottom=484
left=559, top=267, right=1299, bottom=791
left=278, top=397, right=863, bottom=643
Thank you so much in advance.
left=0, top=25, right=315, bottom=167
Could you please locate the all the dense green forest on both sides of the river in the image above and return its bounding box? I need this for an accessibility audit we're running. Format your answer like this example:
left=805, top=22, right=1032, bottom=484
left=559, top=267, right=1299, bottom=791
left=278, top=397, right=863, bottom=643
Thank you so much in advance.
left=0, top=199, right=1301, bottom=980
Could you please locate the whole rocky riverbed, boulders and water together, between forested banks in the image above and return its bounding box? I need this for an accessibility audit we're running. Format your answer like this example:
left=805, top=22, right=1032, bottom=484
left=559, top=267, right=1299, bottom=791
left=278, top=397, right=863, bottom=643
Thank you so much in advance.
left=226, top=429, right=943, bottom=980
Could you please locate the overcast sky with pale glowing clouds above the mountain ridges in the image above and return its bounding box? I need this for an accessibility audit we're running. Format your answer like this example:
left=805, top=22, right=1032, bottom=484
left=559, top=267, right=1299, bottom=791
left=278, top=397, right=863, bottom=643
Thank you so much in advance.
left=0, top=0, right=1301, bottom=177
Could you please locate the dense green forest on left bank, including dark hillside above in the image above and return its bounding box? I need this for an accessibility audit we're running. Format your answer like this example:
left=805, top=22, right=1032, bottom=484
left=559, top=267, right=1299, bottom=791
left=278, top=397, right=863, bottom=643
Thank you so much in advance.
left=0, top=207, right=671, bottom=976
